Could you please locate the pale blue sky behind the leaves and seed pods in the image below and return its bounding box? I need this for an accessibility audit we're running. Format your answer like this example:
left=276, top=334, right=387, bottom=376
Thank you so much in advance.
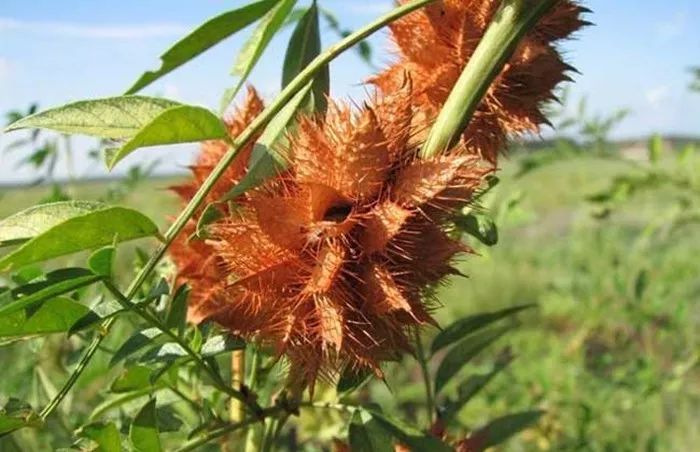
left=0, top=0, right=700, bottom=182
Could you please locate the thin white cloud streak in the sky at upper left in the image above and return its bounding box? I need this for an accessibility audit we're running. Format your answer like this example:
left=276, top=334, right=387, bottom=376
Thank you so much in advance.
left=0, top=17, right=190, bottom=39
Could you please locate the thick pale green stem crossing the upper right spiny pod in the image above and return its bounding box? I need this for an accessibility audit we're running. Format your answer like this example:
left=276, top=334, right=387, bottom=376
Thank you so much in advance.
left=421, top=0, right=557, bottom=158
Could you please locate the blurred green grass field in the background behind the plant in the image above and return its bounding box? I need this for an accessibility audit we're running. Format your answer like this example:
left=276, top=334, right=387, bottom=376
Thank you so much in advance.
left=0, top=150, right=700, bottom=451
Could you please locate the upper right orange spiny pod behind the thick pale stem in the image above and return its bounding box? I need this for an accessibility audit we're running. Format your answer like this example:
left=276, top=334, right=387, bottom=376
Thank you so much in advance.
left=369, top=0, right=587, bottom=164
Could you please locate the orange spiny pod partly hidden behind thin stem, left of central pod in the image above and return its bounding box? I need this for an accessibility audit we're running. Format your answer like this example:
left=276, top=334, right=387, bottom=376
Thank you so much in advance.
left=169, top=87, right=264, bottom=323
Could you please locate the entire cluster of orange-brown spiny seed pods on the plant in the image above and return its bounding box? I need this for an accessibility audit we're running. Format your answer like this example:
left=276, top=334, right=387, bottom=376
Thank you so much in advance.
left=171, top=0, right=584, bottom=384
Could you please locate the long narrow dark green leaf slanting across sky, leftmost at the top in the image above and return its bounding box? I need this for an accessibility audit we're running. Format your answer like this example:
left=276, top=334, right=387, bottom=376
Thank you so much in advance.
left=127, top=0, right=276, bottom=94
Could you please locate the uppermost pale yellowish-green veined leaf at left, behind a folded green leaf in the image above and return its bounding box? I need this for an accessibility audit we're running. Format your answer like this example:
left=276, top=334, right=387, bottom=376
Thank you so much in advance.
left=5, top=96, right=180, bottom=140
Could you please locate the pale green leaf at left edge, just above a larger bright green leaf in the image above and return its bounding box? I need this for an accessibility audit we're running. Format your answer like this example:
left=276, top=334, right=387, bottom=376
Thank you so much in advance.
left=0, top=201, right=105, bottom=247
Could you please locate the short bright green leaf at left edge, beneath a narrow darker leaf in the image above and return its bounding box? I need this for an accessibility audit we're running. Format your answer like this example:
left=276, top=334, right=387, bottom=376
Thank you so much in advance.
left=0, top=297, right=90, bottom=338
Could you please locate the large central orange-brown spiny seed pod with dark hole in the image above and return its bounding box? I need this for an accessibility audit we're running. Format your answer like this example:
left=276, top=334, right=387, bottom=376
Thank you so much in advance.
left=183, top=83, right=489, bottom=384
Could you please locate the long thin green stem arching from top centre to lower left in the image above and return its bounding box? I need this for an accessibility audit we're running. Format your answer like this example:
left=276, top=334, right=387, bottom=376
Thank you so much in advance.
left=41, top=0, right=435, bottom=425
